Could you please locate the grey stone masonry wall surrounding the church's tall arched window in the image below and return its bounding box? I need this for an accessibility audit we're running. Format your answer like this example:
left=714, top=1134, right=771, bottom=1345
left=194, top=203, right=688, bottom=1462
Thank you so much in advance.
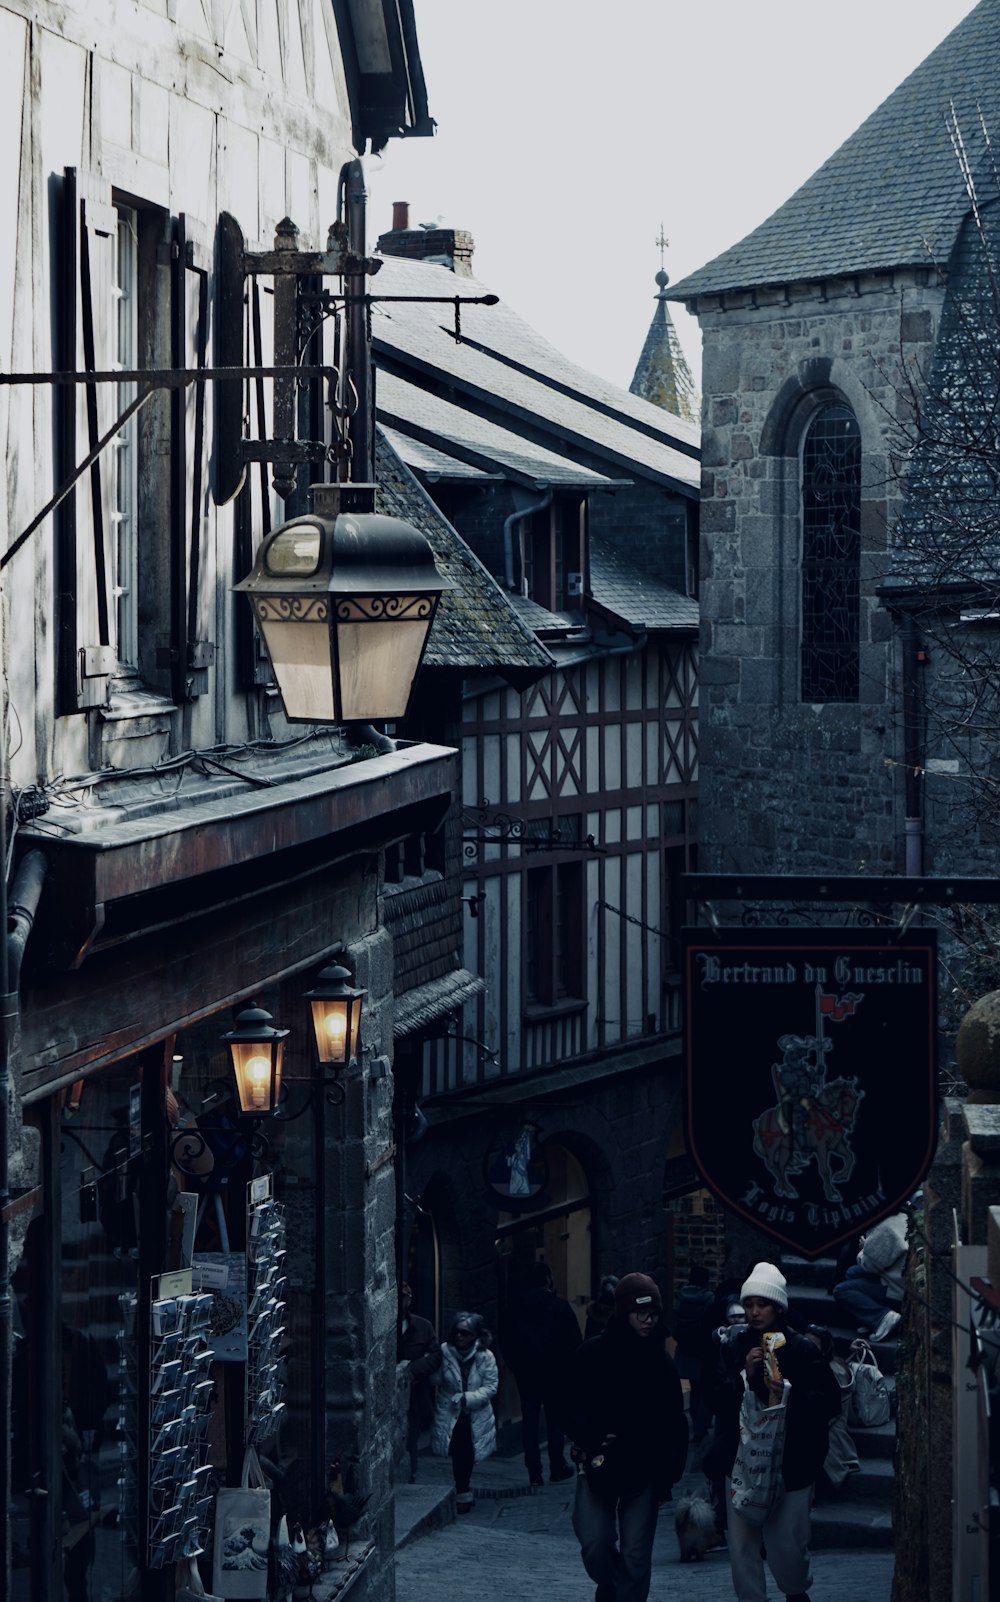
left=699, top=277, right=941, bottom=873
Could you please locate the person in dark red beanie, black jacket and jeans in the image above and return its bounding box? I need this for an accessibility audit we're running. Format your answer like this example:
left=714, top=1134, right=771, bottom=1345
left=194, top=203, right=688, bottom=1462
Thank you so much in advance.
left=567, top=1274, right=688, bottom=1602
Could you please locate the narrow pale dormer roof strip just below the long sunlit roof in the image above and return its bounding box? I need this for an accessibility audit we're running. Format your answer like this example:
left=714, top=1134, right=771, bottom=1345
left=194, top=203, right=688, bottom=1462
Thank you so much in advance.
left=375, top=372, right=630, bottom=490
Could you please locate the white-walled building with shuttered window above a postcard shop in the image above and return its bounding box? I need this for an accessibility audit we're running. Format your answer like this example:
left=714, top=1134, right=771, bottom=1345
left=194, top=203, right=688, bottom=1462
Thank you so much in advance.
left=0, top=0, right=460, bottom=1602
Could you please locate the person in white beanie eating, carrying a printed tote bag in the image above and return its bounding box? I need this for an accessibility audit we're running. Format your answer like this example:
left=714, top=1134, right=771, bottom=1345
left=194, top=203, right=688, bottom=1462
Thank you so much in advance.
left=716, top=1262, right=840, bottom=1602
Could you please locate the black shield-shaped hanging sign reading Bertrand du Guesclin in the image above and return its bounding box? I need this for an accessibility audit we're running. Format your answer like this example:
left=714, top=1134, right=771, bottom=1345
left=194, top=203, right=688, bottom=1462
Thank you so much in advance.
left=684, top=928, right=938, bottom=1258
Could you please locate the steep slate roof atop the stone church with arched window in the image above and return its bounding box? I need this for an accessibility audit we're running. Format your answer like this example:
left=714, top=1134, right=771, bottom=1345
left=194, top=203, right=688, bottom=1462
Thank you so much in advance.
left=668, top=0, right=1000, bottom=300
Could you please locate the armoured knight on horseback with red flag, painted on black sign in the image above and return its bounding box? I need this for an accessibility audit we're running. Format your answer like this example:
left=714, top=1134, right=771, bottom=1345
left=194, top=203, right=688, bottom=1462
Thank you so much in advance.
left=753, top=985, right=864, bottom=1202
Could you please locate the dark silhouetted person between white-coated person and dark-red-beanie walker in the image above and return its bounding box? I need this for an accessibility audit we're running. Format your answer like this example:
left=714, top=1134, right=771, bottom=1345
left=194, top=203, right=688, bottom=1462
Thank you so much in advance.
left=503, top=1262, right=582, bottom=1487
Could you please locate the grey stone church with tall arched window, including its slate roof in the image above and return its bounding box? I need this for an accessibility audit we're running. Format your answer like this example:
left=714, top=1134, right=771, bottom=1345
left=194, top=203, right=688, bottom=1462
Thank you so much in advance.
left=667, top=0, right=1000, bottom=873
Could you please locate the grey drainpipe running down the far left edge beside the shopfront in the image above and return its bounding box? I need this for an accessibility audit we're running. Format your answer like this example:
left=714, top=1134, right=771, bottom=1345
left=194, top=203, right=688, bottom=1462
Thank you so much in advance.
left=0, top=845, right=48, bottom=1596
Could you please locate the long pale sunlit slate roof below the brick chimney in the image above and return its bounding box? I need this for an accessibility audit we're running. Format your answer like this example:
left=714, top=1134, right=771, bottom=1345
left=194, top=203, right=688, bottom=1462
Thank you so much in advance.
left=372, top=256, right=700, bottom=498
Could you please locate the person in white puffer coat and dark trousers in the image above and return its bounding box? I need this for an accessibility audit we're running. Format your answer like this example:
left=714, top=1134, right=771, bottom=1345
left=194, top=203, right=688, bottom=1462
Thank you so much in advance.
left=431, top=1312, right=500, bottom=1512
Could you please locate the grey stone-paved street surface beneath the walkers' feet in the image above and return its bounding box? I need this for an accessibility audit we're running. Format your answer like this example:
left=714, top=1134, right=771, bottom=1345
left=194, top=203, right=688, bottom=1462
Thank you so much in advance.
left=396, top=1458, right=893, bottom=1602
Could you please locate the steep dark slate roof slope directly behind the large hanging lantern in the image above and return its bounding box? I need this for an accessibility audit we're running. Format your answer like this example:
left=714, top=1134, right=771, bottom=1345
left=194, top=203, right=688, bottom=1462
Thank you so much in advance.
left=375, top=431, right=551, bottom=676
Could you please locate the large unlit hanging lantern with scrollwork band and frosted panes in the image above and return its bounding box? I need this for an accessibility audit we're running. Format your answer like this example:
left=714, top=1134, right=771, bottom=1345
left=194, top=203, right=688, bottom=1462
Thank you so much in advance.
left=236, top=484, right=449, bottom=723
